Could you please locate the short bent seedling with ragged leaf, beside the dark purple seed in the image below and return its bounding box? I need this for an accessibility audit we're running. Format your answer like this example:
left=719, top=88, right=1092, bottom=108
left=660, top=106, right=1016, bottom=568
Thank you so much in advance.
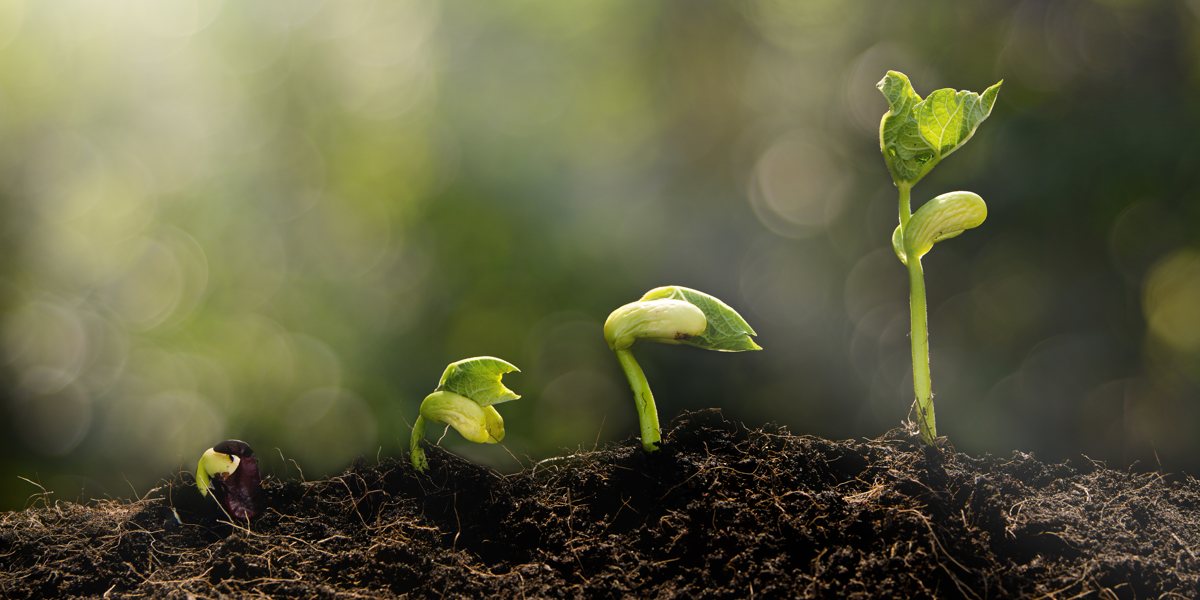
left=408, top=356, right=521, bottom=472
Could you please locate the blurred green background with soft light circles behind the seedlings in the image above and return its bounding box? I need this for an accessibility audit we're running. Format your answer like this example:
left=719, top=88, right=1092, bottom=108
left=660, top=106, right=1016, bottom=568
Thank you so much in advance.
left=0, top=0, right=1200, bottom=509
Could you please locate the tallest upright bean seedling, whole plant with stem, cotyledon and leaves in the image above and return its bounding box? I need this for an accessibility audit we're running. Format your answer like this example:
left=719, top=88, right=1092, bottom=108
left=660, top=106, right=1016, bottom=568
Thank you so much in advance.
left=876, top=71, right=1003, bottom=445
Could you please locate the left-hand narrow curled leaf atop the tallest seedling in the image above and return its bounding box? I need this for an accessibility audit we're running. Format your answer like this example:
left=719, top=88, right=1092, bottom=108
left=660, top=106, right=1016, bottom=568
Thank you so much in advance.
left=876, top=71, right=934, bottom=184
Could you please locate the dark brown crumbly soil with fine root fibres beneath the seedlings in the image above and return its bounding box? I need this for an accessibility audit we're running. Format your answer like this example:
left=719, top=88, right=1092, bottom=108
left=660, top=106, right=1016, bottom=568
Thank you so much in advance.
left=0, top=412, right=1200, bottom=599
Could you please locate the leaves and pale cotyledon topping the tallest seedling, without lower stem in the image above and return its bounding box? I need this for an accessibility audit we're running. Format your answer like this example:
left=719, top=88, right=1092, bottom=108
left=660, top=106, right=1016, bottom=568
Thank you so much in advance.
left=876, top=71, right=1003, bottom=264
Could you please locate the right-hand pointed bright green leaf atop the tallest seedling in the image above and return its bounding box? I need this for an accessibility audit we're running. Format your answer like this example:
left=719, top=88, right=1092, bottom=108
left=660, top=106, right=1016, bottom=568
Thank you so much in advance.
left=913, top=80, right=1004, bottom=161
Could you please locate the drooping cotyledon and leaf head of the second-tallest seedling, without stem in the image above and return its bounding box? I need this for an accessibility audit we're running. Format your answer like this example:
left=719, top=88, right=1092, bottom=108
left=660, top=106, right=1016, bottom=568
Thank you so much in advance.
left=604, top=286, right=762, bottom=352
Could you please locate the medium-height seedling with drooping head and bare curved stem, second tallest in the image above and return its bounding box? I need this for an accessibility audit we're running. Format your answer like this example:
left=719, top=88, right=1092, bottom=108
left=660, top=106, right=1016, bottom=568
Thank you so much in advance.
left=604, top=286, right=762, bottom=452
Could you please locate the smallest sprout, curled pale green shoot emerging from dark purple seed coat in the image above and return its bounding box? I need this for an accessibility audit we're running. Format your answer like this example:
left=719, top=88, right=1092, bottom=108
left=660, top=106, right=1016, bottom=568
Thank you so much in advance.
left=196, top=439, right=264, bottom=521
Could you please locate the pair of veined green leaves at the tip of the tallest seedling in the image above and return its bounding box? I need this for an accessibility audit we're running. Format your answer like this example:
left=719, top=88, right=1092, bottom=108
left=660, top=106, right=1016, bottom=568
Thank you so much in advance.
left=876, top=71, right=1004, bottom=186
